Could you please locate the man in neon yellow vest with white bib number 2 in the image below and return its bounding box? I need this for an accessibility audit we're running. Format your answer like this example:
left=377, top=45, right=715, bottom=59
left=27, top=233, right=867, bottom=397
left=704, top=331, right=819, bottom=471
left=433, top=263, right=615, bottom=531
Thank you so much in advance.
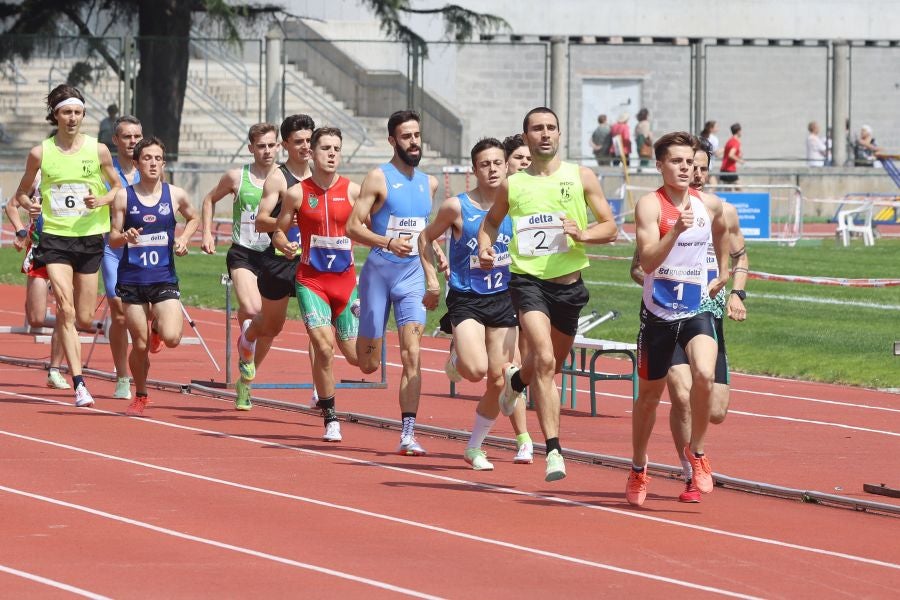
left=478, top=107, right=617, bottom=481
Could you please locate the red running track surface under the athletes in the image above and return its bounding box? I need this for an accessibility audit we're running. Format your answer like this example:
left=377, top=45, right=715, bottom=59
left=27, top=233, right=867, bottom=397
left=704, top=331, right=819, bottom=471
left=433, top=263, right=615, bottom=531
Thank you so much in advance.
left=0, top=286, right=900, bottom=598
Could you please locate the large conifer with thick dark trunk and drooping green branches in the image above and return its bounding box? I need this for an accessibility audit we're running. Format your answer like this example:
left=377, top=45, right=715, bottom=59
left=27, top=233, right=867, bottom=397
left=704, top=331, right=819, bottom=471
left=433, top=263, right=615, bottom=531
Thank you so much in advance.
left=0, top=0, right=508, bottom=155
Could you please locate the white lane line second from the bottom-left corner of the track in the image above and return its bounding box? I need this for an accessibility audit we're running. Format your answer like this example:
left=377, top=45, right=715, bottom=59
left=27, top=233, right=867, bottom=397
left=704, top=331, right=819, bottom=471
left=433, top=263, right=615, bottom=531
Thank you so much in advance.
left=0, top=485, right=440, bottom=599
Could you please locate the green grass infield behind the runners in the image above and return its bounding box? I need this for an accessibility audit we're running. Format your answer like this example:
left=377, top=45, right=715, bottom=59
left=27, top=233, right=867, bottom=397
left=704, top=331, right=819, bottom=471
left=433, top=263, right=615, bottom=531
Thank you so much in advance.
left=0, top=239, right=900, bottom=388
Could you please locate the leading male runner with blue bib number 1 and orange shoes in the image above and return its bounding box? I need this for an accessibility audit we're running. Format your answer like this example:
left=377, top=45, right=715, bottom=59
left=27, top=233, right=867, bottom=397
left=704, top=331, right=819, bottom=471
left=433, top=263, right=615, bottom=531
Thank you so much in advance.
left=625, top=132, right=728, bottom=506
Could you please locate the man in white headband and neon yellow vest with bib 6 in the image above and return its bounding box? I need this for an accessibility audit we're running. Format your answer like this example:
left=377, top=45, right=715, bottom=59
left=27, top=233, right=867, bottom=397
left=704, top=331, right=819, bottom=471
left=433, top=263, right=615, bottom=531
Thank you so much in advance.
left=16, top=84, right=121, bottom=406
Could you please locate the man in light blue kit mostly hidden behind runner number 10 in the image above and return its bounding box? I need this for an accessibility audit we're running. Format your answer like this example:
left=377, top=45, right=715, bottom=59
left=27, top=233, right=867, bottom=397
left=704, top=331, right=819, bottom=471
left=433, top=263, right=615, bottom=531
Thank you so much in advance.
left=100, top=115, right=143, bottom=400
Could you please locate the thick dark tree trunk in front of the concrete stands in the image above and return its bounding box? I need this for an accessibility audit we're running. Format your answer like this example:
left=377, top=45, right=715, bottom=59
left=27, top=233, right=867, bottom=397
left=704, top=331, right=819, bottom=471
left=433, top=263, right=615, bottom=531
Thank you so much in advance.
left=135, top=0, right=191, bottom=160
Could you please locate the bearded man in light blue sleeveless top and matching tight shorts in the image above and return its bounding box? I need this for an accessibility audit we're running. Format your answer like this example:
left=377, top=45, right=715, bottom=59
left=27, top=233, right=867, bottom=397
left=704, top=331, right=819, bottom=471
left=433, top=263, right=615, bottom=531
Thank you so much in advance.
left=347, top=110, right=438, bottom=456
